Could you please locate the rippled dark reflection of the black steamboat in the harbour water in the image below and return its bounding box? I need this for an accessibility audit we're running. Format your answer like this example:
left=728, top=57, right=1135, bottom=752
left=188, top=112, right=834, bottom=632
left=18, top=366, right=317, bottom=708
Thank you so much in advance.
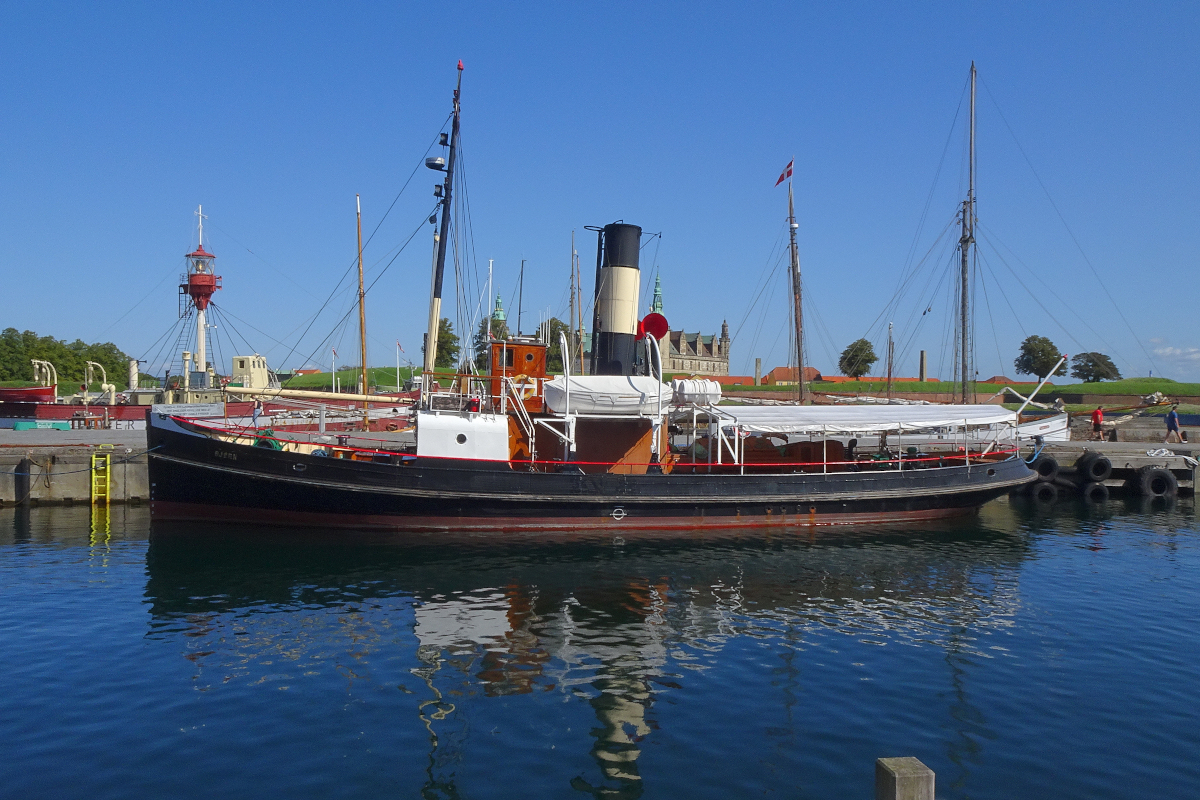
left=146, top=510, right=1025, bottom=798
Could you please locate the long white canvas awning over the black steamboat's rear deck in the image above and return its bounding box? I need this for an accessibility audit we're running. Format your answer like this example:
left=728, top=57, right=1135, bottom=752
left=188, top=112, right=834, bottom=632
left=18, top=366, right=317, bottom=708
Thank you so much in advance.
left=720, top=405, right=1016, bottom=433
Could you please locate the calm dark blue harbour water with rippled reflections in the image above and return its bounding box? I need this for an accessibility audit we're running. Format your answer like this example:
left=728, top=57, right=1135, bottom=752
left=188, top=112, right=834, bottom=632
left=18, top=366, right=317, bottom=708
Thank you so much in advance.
left=0, top=499, right=1200, bottom=799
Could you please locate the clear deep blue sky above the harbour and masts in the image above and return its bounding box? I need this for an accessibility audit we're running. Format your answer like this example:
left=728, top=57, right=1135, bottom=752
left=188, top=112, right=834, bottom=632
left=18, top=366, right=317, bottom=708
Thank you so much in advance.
left=0, top=2, right=1200, bottom=380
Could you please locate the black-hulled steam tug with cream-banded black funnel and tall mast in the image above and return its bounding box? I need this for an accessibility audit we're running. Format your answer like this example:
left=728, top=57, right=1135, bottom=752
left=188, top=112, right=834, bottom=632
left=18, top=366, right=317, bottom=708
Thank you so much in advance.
left=148, top=62, right=1036, bottom=531
